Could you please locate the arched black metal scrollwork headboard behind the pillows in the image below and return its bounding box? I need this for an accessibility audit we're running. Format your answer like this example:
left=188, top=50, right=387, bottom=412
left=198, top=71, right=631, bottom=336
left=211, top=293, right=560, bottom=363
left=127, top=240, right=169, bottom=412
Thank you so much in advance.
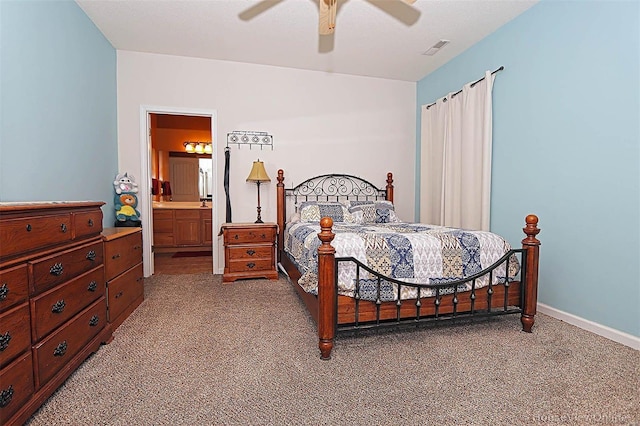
left=285, top=174, right=387, bottom=208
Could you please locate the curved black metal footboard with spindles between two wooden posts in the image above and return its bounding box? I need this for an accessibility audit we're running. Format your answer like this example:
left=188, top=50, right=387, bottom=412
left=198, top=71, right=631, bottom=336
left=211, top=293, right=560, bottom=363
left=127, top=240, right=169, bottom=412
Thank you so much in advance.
left=334, top=248, right=527, bottom=332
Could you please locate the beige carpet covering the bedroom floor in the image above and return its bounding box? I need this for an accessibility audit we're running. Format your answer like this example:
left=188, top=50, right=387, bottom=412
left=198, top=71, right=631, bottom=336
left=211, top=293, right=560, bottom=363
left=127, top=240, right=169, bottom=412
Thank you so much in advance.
left=28, top=274, right=640, bottom=426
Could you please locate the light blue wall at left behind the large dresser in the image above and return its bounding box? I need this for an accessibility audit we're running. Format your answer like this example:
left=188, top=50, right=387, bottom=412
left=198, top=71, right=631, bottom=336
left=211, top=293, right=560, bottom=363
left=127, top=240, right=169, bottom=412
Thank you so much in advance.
left=0, top=0, right=118, bottom=226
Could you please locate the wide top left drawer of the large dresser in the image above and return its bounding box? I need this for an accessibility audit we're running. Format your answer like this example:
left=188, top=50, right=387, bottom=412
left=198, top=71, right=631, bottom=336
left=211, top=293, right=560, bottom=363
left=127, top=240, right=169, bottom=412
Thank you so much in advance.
left=0, top=213, right=72, bottom=257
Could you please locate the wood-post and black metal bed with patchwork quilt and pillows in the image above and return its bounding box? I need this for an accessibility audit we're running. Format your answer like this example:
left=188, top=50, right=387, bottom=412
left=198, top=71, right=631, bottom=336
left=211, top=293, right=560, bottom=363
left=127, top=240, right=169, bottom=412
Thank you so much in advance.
left=276, top=170, right=540, bottom=360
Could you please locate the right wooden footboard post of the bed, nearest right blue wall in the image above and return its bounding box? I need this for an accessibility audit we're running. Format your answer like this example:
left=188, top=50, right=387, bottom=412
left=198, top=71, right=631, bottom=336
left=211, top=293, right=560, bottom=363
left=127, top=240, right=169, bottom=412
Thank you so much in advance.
left=520, top=214, right=540, bottom=333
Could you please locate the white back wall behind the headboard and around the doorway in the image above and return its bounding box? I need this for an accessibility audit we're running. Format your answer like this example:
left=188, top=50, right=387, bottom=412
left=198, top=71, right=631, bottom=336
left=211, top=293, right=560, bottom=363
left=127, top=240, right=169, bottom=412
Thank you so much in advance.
left=117, top=51, right=416, bottom=272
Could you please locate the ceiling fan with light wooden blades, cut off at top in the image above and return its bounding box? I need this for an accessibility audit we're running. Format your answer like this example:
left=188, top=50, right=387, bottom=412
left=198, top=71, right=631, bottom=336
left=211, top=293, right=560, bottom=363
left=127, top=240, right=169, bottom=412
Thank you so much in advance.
left=238, top=0, right=420, bottom=35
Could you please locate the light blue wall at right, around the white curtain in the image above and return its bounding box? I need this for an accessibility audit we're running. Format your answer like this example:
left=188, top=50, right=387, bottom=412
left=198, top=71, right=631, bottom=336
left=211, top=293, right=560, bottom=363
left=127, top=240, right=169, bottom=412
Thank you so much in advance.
left=416, top=1, right=640, bottom=336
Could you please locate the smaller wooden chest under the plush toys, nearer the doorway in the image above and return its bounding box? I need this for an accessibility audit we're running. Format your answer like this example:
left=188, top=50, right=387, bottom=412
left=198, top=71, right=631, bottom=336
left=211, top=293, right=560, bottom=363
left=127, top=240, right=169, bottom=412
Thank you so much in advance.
left=102, top=228, right=144, bottom=331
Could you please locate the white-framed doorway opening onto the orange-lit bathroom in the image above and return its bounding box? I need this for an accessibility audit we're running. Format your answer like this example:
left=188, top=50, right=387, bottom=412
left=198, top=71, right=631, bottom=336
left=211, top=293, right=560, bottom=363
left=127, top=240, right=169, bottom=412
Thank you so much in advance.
left=140, top=106, right=221, bottom=276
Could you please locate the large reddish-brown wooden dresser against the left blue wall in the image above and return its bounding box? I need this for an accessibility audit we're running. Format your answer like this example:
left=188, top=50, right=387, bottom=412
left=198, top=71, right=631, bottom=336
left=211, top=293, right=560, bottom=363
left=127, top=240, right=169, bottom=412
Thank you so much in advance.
left=0, top=202, right=111, bottom=425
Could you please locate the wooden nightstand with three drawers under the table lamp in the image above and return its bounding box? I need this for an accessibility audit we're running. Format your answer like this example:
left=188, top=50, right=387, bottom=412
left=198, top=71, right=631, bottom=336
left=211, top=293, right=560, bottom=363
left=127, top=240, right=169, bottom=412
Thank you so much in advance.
left=220, top=223, right=278, bottom=283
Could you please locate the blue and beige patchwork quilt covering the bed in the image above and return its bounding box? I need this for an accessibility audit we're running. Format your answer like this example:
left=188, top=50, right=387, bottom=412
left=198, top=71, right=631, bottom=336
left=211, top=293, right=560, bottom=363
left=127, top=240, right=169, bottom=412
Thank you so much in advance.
left=284, top=221, right=520, bottom=301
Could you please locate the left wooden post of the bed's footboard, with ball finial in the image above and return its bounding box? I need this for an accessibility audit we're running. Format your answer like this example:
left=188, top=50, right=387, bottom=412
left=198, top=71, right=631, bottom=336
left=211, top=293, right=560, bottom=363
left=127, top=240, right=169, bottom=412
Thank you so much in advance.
left=318, top=217, right=337, bottom=360
